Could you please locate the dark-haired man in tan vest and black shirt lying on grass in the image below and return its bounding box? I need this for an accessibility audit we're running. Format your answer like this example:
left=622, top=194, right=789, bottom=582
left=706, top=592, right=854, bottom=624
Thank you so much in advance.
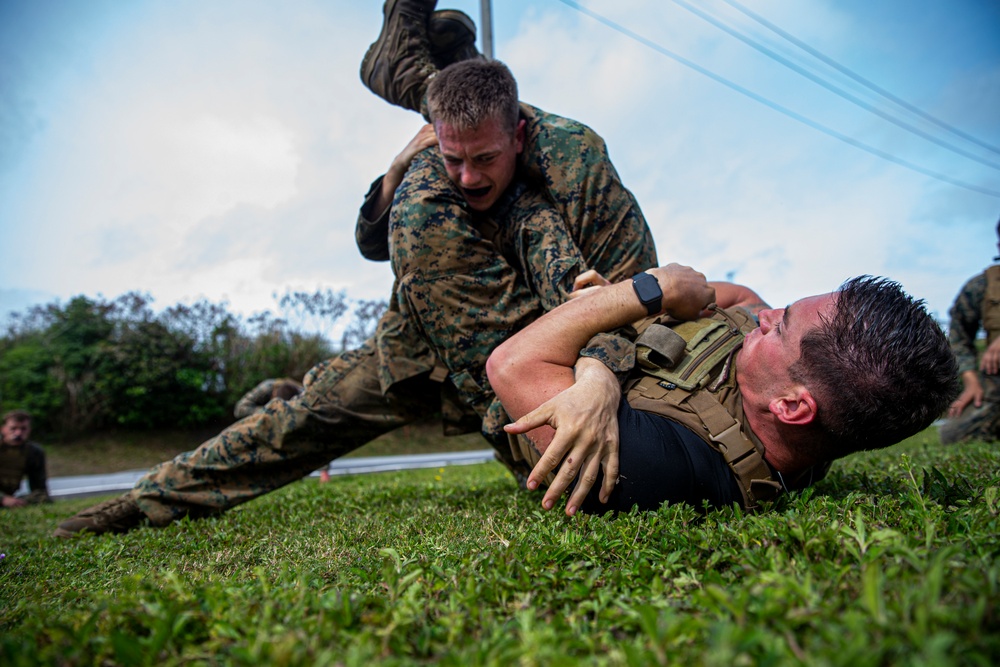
left=487, top=264, right=956, bottom=515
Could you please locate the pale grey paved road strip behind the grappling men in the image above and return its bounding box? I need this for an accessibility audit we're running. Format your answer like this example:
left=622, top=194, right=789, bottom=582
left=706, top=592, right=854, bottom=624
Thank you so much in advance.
left=30, top=449, right=493, bottom=498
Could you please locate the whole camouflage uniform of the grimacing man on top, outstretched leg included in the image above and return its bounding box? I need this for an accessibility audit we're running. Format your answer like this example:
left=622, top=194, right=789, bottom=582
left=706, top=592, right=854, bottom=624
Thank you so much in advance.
left=133, top=105, right=656, bottom=525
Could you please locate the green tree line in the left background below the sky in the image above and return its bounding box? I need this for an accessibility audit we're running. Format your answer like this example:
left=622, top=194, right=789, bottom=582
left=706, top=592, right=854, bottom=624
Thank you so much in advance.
left=0, top=290, right=387, bottom=437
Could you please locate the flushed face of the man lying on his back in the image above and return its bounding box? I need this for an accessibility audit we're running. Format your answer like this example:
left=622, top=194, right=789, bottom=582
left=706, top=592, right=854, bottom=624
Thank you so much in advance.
left=736, top=293, right=837, bottom=403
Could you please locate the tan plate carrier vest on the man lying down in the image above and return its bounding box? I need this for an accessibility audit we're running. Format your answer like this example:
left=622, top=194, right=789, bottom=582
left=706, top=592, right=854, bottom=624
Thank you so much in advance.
left=510, top=308, right=783, bottom=510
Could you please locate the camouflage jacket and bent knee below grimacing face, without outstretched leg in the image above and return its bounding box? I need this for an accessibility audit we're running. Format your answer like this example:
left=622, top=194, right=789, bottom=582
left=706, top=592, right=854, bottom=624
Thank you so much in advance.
left=388, top=104, right=656, bottom=439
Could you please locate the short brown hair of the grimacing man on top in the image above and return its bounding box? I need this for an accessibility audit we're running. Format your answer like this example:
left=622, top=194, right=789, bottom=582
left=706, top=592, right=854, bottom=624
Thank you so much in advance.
left=427, top=59, right=520, bottom=132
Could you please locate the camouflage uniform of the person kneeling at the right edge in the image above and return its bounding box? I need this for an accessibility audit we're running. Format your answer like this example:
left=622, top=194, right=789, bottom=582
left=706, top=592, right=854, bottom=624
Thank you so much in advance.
left=939, top=267, right=1000, bottom=444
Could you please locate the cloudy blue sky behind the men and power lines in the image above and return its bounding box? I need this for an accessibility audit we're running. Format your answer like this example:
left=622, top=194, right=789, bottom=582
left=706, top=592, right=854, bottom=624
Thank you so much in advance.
left=0, top=0, right=1000, bottom=328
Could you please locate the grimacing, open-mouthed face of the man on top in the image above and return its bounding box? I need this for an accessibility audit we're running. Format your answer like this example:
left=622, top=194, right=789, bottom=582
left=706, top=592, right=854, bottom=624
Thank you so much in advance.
left=434, top=118, right=524, bottom=211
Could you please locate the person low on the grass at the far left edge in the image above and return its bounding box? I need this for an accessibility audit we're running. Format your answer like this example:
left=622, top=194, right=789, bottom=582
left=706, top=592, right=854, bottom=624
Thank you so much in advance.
left=0, top=410, right=52, bottom=508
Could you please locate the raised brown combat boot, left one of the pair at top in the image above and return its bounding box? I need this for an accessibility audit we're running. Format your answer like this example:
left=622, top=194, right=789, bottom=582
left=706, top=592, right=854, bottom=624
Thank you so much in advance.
left=361, top=0, right=438, bottom=112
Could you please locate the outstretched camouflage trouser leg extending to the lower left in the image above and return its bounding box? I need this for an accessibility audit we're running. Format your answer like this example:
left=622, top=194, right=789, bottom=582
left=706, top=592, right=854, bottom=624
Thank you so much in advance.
left=132, top=340, right=442, bottom=525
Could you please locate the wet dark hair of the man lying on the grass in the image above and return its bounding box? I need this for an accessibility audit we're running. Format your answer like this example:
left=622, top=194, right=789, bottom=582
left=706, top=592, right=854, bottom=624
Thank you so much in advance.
left=789, top=276, right=958, bottom=460
